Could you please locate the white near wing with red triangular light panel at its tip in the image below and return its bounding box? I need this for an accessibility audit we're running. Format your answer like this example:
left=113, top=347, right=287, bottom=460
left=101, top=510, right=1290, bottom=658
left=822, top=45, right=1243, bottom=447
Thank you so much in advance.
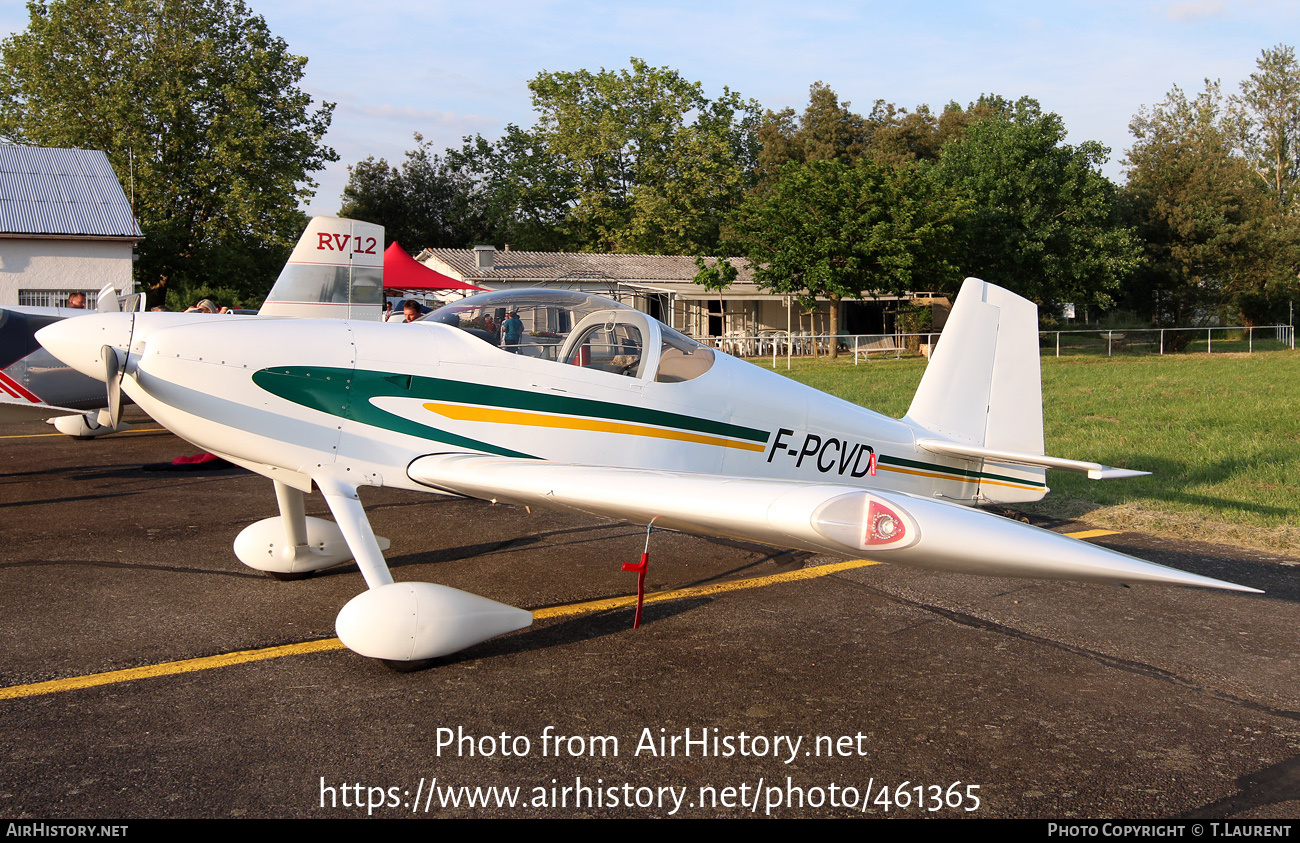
left=407, top=453, right=1256, bottom=591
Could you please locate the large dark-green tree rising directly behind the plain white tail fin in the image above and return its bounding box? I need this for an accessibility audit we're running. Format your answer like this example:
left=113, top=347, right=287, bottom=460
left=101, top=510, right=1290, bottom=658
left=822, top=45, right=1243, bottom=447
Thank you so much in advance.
left=933, top=98, right=1140, bottom=304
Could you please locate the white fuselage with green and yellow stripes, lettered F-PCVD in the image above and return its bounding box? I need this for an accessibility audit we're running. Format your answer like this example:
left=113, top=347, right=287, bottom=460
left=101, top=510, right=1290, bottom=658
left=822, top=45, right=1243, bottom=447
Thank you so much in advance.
left=104, top=314, right=1043, bottom=501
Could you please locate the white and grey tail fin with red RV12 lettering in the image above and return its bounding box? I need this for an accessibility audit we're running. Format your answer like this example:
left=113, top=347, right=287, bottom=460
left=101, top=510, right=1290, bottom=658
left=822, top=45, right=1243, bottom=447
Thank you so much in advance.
left=259, top=217, right=384, bottom=320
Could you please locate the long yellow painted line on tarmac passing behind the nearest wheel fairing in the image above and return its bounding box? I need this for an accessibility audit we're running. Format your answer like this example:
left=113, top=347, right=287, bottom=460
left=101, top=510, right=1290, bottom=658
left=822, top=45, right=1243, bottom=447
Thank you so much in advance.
left=0, top=559, right=879, bottom=700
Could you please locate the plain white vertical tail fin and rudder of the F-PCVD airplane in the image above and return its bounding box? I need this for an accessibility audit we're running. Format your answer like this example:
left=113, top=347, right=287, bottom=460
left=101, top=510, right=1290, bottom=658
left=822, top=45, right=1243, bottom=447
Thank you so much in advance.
left=906, top=278, right=1044, bottom=502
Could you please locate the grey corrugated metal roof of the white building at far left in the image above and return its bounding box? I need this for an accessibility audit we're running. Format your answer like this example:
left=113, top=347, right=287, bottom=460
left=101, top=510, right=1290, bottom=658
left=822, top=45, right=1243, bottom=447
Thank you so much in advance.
left=0, top=146, right=143, bottom=238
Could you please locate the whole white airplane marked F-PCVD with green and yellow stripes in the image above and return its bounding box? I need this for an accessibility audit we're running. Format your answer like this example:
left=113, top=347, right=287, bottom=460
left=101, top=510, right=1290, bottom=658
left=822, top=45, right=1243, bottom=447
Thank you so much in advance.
left=39, top=224, right=1256, bottom=663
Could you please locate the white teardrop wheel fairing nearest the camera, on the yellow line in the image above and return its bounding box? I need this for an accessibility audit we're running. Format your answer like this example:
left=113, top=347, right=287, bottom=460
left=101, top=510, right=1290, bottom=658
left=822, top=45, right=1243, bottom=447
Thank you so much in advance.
left=334, top=583, right=533, bottom=661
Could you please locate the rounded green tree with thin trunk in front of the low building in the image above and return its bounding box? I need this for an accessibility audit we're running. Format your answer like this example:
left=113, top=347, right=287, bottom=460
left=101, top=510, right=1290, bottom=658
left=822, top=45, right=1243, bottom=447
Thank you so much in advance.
left=722, top=159, right=958, bottom=353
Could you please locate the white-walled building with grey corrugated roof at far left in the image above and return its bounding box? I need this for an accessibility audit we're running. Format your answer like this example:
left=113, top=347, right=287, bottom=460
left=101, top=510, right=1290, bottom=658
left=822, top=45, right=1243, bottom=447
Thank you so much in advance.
left=0, top=146, right=144, bottom=307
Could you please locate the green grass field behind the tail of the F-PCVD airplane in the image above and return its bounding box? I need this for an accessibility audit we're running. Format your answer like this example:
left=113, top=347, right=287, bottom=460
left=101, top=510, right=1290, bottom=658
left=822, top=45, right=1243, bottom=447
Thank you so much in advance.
left=755, top=351, right=1300, bottom=555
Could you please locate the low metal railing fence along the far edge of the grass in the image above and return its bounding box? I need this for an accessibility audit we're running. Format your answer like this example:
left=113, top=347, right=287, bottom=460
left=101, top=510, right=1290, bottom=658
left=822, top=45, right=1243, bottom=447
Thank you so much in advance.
left=699, top=325, right=1296, bottom=367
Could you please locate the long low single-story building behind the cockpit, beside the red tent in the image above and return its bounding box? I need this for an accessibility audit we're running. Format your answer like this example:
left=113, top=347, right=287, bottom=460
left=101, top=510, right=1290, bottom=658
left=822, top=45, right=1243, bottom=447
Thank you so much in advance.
left=416, top=246, right=910, bottom=338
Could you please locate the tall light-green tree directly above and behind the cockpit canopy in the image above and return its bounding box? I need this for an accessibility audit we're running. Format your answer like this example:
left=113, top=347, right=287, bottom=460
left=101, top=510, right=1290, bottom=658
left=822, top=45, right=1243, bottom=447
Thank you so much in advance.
left=529, top=59, right=758, bottom=254
